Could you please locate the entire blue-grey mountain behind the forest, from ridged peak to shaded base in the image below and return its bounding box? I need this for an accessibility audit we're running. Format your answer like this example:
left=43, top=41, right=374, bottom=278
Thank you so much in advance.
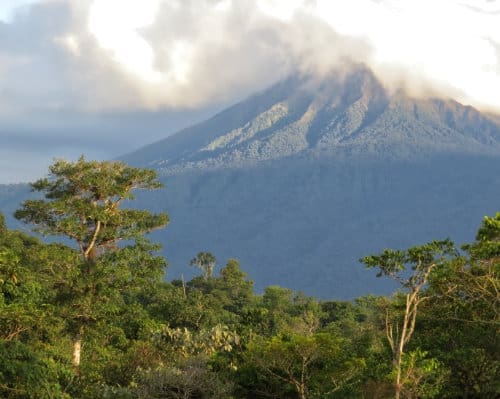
left=0, top=68, right=500, bottom=298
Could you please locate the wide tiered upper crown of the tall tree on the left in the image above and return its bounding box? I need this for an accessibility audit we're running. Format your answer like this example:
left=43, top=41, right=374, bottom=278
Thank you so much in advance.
left=15, top=156, right=168, bottom=259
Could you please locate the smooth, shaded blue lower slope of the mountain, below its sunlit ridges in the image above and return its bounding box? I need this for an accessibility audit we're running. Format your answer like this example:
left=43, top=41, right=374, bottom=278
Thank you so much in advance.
left=130, top=155, right=500, bottom=299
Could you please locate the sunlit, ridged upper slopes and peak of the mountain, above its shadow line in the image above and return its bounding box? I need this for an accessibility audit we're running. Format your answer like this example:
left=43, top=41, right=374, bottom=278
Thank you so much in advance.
left=123, top=69, right=500, bottom=174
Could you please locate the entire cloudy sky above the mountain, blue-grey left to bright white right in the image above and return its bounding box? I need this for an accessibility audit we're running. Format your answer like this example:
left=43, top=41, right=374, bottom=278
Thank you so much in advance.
left=0, top=0, right=500, bottom=183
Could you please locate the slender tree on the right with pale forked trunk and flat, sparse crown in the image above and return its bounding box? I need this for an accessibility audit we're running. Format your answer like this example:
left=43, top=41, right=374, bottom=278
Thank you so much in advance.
left=360, top=240, right=456, bottom=399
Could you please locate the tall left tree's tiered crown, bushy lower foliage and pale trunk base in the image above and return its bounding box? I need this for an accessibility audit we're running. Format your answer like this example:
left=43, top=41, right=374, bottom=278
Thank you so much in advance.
left=9, top=157, right=168, bottom=384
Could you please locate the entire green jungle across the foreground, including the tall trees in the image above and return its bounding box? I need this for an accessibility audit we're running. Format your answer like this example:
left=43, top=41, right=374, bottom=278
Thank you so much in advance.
left=0, top=158, right=500, bottom=399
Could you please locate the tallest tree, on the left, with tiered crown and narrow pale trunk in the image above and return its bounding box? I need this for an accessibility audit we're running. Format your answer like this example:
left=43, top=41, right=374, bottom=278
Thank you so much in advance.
left=15, top=156, right=168, bottom=370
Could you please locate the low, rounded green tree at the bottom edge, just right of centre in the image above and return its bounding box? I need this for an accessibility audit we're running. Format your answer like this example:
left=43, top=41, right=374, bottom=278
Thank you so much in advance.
left=243, top=333, right=365, bottom=399
